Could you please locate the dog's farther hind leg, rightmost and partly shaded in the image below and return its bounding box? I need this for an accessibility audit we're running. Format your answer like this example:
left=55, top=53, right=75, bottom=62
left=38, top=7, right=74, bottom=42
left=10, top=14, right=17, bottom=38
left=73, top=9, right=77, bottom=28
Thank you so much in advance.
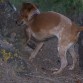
left=69, top=45, right=78, bottom=70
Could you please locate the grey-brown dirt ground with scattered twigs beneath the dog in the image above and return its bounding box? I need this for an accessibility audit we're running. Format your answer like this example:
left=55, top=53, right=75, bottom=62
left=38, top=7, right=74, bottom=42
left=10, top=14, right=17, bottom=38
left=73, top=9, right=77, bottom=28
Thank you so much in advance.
left=0, top=31, right=83, bottom=83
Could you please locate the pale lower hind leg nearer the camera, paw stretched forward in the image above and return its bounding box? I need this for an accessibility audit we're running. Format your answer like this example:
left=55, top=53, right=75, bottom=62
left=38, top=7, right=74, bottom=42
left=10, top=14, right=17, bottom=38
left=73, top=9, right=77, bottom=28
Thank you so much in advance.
left=53, top=46, right=67, bottom=74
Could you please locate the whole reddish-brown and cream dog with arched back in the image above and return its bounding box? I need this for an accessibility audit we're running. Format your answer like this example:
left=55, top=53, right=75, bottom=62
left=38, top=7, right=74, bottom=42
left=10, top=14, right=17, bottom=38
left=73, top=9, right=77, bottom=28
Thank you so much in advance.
left=17, top=3, right=83, bottom=74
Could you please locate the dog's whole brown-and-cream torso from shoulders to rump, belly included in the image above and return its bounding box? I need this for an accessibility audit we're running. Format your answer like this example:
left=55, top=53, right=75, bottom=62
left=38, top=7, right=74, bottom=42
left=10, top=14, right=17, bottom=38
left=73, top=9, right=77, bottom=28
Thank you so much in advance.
left=29, top=12, right=78, bottom=42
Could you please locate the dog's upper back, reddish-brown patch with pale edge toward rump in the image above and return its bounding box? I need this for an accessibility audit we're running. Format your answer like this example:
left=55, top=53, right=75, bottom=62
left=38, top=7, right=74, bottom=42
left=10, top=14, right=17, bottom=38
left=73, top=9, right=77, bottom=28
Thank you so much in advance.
left=30, top=12, right=72, bottom=32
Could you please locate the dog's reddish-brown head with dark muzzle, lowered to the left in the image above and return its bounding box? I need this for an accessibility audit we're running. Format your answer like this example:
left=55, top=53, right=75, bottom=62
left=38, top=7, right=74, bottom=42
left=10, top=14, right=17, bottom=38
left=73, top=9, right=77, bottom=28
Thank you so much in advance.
left=16, top=3, right=40, bottom=25
